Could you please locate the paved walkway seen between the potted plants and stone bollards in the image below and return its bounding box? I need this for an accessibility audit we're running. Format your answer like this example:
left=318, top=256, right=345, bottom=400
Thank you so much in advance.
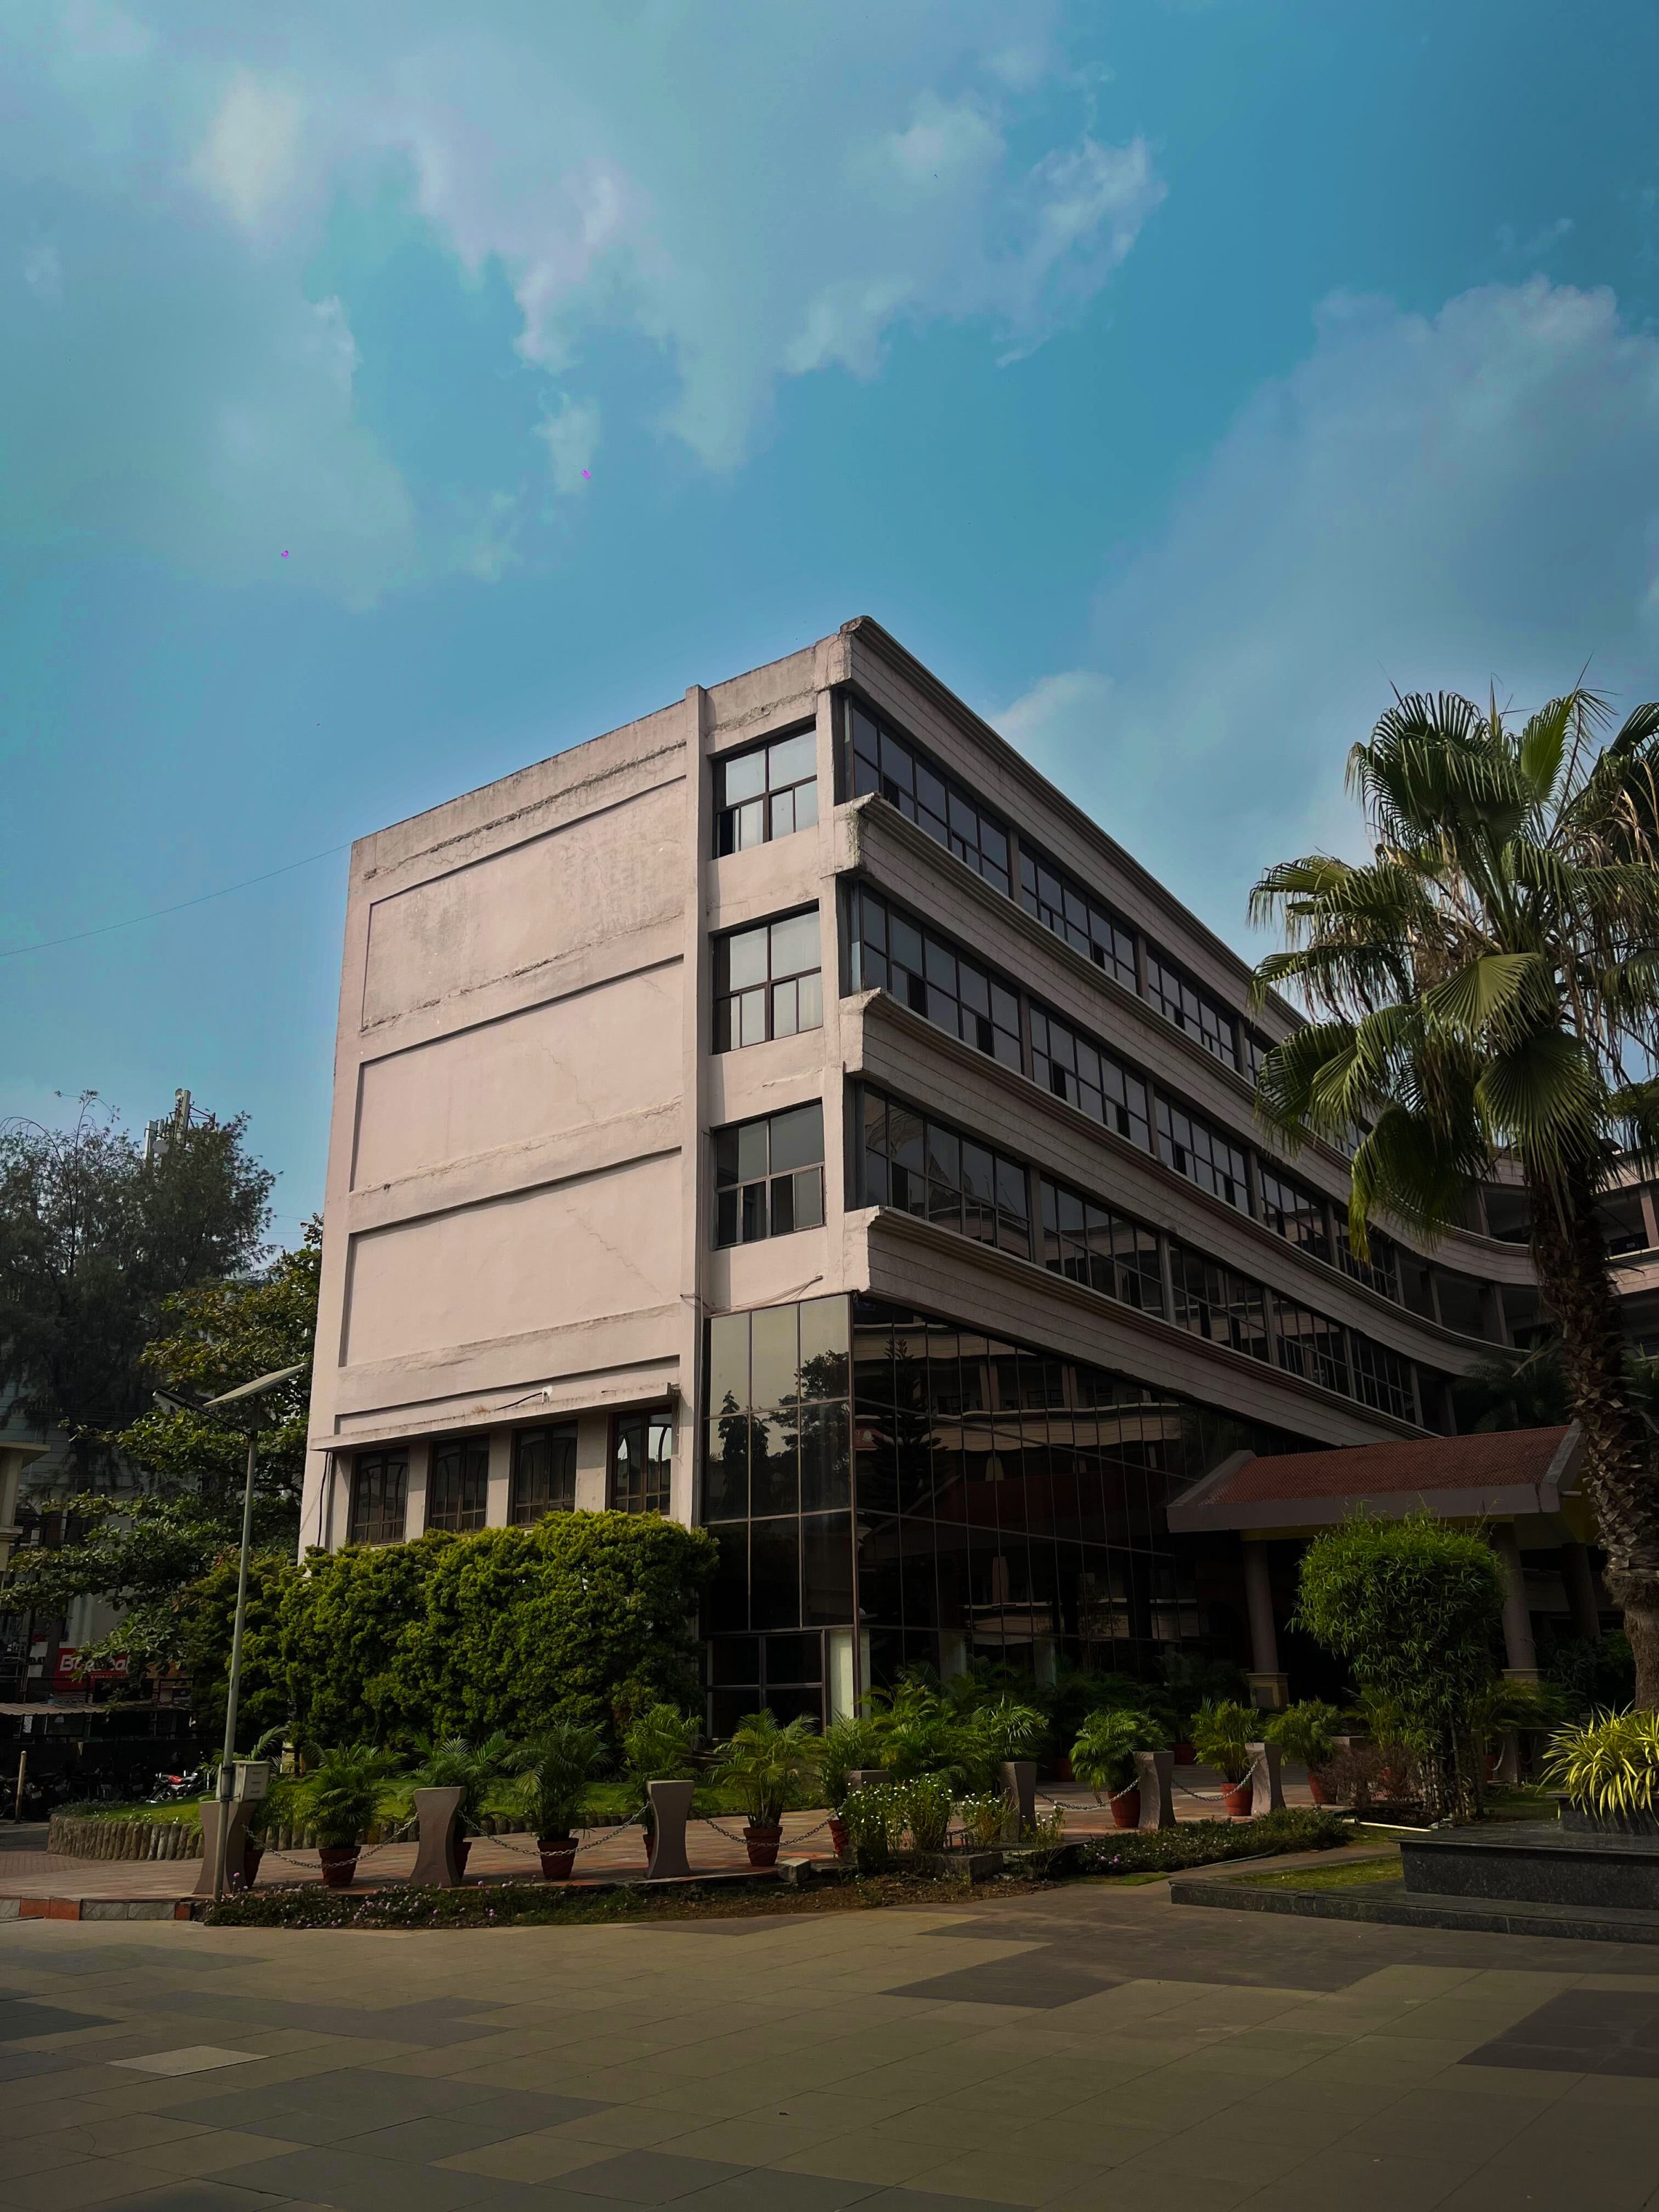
left=0, top=1768, right=1307, bottom=1900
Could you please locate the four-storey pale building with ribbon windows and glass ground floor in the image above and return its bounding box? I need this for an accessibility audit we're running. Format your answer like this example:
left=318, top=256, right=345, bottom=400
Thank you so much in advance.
left=303, top=619, right=1659, bottom=1727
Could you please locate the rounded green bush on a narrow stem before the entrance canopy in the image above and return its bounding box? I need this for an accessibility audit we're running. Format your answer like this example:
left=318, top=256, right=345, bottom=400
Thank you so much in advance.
left=1296, top=1513, right=1504, bottom=1816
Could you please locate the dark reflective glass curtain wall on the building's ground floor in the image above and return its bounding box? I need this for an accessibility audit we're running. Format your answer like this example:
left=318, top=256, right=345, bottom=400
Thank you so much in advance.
left=701, top=1296, right=1307, bottom=1730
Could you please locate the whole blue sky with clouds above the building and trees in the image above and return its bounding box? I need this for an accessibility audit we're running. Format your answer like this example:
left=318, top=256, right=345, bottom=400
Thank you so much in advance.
left=0, top=0, right=1659, bottom=1237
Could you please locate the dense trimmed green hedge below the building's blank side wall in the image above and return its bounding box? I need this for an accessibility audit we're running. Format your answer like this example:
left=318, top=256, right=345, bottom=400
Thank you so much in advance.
left=190, top=1513, right=717, bottom=1745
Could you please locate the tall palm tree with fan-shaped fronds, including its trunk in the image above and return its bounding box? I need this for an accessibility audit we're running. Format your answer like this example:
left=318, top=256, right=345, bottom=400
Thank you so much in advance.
left=1250, top=690, right=1659, bottom=1707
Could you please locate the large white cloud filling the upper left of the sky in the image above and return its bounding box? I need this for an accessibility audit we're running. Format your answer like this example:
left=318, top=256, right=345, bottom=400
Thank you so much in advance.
left=0, top=0, right=1161, bottom=595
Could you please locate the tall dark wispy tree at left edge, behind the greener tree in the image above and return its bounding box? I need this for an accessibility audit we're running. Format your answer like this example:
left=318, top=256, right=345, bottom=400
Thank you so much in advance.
left=0, top=1093, right=272, bottom=1484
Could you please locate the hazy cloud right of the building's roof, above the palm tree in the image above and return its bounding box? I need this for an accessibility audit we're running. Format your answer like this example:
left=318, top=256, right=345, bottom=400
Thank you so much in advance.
left=995, top=279, right=1659, bottom=942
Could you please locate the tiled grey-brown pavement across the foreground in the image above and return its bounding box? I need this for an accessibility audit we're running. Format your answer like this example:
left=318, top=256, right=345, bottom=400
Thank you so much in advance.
left=0, top=1884, right=1659, bottom=2212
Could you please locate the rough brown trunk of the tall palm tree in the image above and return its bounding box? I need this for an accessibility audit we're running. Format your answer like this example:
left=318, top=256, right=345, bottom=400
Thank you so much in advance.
left=1526, top=1168, right=1659, bottom=1710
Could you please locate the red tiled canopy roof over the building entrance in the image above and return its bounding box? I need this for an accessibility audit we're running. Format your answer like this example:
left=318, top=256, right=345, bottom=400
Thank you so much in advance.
left=1170, top=1427, right=1580, bottom=1530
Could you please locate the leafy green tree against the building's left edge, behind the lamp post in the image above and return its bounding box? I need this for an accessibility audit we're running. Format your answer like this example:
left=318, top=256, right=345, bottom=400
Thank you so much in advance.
left=7, top=1224, right=323, bottom=1666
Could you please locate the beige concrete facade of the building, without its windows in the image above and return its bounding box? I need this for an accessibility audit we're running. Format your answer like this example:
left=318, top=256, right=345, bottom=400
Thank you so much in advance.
left=303, top=621, right=1654, bottom=1698
